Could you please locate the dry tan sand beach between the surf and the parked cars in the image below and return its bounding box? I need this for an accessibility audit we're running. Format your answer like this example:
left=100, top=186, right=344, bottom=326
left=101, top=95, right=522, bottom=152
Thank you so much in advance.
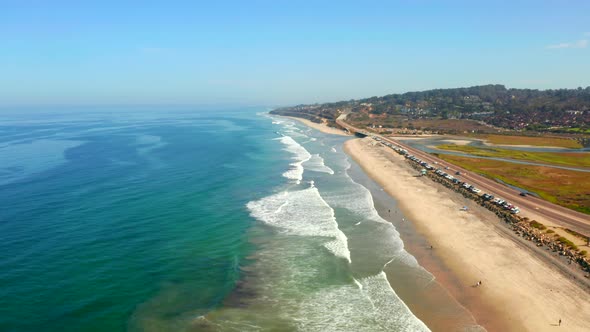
left=344, top=138, right=590, bottom=331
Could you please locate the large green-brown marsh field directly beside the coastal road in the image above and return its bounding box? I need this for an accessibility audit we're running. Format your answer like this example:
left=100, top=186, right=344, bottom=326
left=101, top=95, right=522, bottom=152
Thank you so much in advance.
left=439, top=154, right=590, bottom=214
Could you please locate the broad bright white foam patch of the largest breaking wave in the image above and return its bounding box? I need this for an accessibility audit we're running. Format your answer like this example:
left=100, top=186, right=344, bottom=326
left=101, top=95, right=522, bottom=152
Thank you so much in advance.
left=247, top=185, right=350, bottom=262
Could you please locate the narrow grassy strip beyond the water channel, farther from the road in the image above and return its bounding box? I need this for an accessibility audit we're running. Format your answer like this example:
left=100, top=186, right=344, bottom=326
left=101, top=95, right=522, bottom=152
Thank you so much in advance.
left=437, top=144, right=590, bottom=167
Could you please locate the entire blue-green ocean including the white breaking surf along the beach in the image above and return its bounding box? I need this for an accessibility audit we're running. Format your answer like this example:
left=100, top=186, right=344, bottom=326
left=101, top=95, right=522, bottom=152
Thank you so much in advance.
left=0, top=107, right=444, bottom=332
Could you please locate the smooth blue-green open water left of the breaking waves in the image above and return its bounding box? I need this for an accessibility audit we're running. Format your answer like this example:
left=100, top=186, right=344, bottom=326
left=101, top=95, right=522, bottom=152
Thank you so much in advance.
left=0, top=109, right=288, bottom=331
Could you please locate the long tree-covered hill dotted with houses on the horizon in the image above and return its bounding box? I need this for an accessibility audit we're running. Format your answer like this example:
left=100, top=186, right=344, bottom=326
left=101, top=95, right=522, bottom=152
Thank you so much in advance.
left=272, top=84, right=590, bottom=133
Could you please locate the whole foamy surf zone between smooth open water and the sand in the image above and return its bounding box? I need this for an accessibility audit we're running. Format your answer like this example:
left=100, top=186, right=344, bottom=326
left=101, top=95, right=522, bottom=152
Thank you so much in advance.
left=204, top=121, right=428, bottom=332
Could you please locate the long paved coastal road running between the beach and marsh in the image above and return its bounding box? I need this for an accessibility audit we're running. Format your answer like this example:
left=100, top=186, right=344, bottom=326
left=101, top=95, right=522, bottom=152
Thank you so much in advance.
left=336, top=119, right=590, bottom=236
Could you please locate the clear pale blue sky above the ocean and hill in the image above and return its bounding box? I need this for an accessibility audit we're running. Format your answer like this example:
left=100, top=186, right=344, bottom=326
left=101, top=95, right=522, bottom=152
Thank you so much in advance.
left=0, top=0, right=590, bottom=106
